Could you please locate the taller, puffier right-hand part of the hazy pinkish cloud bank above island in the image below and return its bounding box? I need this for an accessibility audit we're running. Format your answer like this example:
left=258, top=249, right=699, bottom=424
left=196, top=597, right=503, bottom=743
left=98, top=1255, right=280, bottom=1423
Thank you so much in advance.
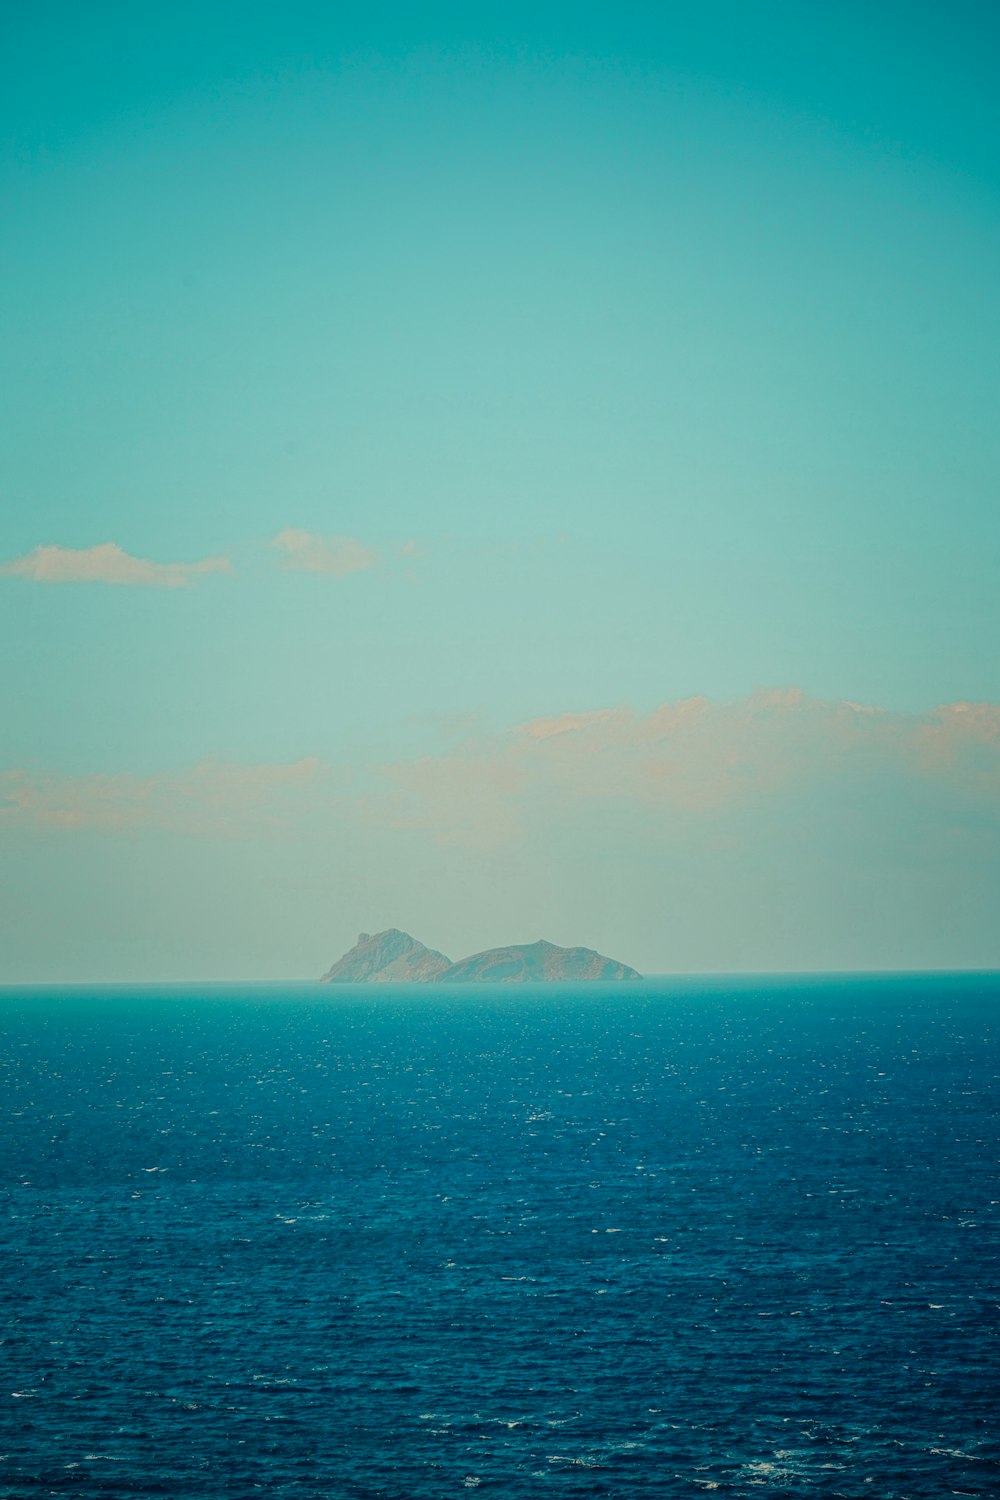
left=374, top=689, right=1000, bottom=846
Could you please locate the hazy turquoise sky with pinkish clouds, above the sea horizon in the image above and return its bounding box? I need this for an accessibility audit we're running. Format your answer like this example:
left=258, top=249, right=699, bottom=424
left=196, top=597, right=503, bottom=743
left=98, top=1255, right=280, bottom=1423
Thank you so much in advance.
left=0, top=0, right=1000, bottom=983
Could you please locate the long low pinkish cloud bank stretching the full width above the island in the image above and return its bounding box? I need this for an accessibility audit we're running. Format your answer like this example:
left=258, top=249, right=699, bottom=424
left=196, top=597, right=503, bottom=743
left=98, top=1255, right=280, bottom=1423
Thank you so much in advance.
left=0, top=689, right=1000, bottom=849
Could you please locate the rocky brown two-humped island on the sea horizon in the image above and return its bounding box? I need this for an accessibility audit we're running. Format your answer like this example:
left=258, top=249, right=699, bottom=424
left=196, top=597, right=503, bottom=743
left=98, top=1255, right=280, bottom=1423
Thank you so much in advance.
left=322, top=927, right=642, bottom=984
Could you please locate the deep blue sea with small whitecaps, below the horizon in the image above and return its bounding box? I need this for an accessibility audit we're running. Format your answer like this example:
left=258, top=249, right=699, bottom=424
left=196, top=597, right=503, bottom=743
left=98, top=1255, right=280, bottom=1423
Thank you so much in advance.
left=0, top=975, right=1000, bottom=1500
